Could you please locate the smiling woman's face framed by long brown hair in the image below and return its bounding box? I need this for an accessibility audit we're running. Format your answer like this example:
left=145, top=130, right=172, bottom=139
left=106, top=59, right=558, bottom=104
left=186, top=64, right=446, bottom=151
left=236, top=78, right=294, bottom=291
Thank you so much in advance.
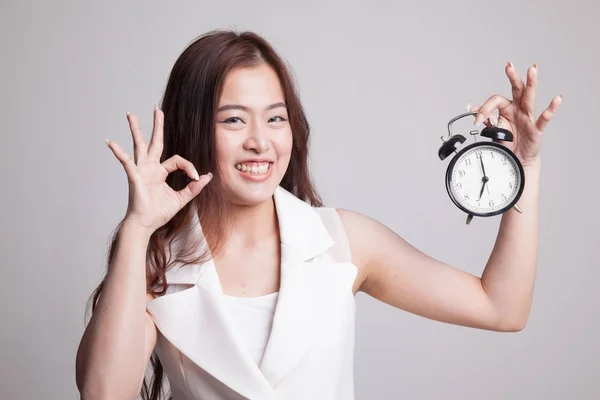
left=215, top=64, right=292, bottom=205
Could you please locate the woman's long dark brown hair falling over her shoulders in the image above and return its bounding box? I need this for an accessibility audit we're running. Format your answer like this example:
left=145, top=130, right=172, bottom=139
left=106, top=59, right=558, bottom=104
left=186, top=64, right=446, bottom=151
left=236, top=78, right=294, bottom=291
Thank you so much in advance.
left=85, top=30, right=322, bottom=400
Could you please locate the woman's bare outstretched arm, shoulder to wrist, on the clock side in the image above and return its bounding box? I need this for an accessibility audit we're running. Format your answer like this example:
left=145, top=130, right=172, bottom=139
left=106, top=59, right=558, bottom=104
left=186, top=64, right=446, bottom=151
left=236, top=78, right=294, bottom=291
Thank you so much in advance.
left=338, top=159, right=539, bottom=331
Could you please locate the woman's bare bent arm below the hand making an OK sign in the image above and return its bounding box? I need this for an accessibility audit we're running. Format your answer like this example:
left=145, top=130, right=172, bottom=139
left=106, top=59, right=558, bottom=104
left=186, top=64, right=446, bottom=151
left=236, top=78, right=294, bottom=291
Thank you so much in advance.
left=76, top=222, right=156, bottom=399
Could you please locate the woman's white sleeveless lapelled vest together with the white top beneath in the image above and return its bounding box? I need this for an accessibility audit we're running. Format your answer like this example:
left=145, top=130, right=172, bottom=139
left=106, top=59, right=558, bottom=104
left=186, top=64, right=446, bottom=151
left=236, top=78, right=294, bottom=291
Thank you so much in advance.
left=147, top=187, right=357, bottom=400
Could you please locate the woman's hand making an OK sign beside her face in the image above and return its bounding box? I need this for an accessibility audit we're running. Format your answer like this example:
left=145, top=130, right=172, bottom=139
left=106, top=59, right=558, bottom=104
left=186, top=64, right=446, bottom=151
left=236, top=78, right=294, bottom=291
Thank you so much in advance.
left=106, top=108, right=212, bottom=233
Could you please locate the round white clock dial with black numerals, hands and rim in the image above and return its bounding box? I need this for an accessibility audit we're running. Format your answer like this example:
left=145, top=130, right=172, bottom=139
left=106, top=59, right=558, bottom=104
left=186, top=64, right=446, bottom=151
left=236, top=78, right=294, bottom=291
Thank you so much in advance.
left=447, top=142, right=523, bottom=215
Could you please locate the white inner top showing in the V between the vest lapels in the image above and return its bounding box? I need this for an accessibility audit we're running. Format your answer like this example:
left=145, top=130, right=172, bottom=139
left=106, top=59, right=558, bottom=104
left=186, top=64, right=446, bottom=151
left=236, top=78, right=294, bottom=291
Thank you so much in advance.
left=224, top=292, right=279, bottom=365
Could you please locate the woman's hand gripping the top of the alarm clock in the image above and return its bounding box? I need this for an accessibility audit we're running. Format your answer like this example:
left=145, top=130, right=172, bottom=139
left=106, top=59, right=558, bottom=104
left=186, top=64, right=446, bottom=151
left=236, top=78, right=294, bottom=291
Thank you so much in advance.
left=467, top=63, right=563, bottom=167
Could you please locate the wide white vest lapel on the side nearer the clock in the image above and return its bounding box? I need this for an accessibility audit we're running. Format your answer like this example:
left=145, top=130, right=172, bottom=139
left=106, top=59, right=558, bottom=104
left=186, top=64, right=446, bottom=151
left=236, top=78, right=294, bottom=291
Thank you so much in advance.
left=260, top=188, right=334, bottom=387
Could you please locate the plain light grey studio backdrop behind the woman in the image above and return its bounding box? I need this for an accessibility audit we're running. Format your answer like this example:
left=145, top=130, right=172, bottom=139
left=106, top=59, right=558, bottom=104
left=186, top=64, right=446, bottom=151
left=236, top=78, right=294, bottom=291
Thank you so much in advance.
left=0, top=0, right=600, bottom=400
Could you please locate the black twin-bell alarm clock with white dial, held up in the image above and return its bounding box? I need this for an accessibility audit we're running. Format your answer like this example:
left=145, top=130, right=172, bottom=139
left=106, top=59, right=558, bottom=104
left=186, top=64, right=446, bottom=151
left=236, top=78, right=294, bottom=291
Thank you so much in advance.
left=438, top=112, right=525, bottom=224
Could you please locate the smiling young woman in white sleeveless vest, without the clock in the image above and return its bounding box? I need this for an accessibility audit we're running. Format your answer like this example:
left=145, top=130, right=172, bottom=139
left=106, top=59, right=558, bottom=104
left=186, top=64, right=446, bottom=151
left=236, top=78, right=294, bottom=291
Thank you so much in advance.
left=76, top=31, right=562, bottom=400
